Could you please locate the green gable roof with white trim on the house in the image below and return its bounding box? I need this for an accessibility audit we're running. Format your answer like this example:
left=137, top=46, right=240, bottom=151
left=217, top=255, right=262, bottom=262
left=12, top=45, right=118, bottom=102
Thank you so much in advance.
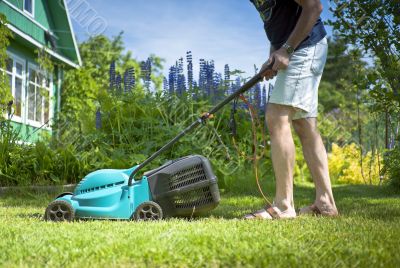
left=0, top=0, right=81, bottom=68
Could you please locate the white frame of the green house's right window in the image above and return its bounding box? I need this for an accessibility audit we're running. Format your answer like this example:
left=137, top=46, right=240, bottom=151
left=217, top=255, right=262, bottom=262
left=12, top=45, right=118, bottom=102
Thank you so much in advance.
left=25, top=63, right=53, bottom=130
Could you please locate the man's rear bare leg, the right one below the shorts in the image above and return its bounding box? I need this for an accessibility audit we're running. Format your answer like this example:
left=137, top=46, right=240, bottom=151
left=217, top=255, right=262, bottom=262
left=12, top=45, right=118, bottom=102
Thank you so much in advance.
left=293, top=118, right=337, bottom=215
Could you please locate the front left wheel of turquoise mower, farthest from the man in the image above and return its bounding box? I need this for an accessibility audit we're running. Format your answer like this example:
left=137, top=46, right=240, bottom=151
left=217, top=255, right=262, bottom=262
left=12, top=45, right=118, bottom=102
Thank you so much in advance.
left=44, top=200, right=75, bottom=222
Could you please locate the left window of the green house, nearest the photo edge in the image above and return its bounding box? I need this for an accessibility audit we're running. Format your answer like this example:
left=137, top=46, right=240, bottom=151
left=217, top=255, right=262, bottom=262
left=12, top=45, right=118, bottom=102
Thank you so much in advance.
left=1, top=56, right=25, bottom=122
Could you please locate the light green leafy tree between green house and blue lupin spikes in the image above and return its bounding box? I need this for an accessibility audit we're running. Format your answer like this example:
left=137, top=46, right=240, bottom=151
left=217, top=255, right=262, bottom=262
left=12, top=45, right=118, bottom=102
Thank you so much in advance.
left=60, top=32, right=162, bottom=134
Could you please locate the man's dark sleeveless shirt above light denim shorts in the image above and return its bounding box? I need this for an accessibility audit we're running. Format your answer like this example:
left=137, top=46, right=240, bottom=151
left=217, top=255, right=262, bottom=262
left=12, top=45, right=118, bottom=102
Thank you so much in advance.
left=250, top=0, right=326, bottom=50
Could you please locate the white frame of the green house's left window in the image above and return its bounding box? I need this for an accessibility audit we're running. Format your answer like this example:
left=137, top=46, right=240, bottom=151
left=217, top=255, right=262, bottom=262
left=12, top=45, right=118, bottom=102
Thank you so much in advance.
left=1, top=51, right=26, bottom=123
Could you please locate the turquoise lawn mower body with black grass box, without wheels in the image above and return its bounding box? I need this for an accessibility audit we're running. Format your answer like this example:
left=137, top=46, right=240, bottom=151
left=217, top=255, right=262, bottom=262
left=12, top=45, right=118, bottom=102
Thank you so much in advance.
left=46, top=155, right=220, bottom=220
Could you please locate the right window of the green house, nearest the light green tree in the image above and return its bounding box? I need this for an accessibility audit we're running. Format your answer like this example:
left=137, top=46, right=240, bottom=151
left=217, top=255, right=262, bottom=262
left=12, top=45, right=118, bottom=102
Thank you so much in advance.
left=27, top=66, right=52, bottom=127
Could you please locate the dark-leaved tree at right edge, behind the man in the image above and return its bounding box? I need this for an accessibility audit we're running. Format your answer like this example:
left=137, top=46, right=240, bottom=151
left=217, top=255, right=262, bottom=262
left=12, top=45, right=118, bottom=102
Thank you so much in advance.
left=330, top=0, right=400, bottom=186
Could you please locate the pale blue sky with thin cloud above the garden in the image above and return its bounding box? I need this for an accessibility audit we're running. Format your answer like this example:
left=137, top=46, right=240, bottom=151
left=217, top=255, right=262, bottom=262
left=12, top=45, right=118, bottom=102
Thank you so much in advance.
left=67, top=0, right=331, bottom=79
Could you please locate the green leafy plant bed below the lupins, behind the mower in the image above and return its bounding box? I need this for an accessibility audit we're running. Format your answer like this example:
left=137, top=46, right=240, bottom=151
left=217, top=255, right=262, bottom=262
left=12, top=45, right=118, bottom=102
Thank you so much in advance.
left=0, top=84, right=271, bottom=189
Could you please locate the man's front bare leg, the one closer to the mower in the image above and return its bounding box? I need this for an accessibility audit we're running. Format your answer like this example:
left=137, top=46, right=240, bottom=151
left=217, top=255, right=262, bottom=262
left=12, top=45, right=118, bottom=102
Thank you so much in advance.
left=266, top=103, right=295, bottom=211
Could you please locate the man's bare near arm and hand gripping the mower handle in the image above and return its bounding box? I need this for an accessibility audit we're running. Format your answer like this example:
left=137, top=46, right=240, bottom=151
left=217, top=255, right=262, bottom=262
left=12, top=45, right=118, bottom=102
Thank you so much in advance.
left=263, top=0, right=322, bottom=78
